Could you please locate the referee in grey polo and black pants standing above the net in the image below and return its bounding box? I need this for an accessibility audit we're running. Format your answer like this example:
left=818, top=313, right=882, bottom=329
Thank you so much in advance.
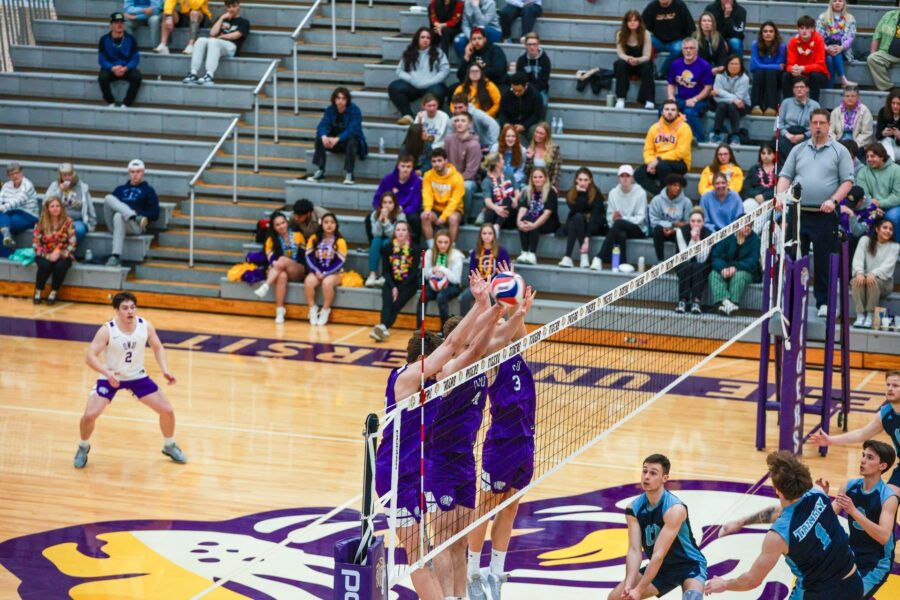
left=776, top=108, right=853, bottom=317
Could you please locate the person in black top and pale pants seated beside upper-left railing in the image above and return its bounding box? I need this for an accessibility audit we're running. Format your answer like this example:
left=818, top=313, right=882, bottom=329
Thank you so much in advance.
left=181, top=0, right=250, bottom=85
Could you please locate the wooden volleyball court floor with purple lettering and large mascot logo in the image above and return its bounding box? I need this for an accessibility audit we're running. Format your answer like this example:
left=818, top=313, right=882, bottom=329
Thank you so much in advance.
left=0, top=298, right=900, bottom=600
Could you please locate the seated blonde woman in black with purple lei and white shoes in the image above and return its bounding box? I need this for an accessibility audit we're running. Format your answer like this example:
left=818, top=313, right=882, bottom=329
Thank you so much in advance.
left=512, top=167, right=559, bottom=265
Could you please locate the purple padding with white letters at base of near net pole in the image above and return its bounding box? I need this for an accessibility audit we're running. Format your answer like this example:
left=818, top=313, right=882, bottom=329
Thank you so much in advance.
left=332, top=536, right=387, bottom=600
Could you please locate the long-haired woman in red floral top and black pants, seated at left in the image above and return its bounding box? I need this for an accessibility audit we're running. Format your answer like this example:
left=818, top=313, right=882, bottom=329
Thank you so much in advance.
left=31, top=196, right=77, bottom=304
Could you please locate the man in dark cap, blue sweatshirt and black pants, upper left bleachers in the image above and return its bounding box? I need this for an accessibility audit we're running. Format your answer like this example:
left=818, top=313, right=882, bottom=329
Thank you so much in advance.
left=97, top=13, right=141, bottom=107
